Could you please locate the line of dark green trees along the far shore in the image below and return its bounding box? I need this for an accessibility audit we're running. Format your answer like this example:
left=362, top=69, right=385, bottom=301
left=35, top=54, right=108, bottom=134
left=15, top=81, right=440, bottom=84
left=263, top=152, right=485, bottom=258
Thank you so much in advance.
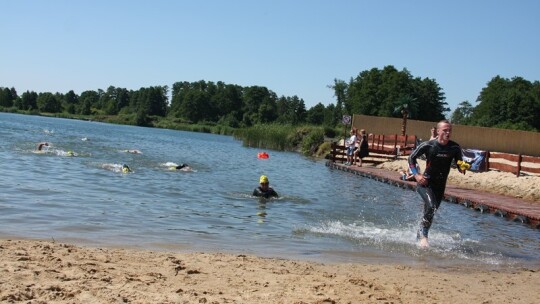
left=0, top=65, right=540, bottom=130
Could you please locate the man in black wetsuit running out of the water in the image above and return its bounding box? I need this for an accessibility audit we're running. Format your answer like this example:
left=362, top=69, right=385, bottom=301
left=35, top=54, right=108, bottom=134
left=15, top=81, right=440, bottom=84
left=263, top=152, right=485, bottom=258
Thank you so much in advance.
left=408, top=120, right=466, bottom=248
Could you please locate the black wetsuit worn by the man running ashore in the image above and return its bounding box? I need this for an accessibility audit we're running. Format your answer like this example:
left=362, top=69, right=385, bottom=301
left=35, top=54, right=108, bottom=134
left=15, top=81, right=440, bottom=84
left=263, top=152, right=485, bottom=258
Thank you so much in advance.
left=409, top=139, right=462, bottom=237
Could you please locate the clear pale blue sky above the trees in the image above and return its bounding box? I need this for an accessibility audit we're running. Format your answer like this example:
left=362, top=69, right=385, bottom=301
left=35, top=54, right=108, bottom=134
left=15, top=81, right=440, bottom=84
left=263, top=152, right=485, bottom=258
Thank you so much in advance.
left=0, top=0, right=540, bottom=114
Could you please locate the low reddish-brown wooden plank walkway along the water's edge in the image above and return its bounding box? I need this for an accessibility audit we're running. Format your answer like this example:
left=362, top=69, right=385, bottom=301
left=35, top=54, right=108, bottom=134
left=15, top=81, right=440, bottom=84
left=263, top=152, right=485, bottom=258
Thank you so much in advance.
left=326, top=160, right=540, bottom=229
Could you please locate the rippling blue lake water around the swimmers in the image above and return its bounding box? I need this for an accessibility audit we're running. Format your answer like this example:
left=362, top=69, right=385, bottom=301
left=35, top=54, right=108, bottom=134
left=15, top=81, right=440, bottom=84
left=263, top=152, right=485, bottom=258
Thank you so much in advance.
left=0, top=113, right=540, bottom=266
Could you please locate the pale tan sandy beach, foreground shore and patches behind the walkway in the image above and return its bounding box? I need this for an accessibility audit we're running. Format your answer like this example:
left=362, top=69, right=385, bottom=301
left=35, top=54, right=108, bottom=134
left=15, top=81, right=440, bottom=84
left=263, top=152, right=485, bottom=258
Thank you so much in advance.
left=0, top=160, right=540, bottom=304
